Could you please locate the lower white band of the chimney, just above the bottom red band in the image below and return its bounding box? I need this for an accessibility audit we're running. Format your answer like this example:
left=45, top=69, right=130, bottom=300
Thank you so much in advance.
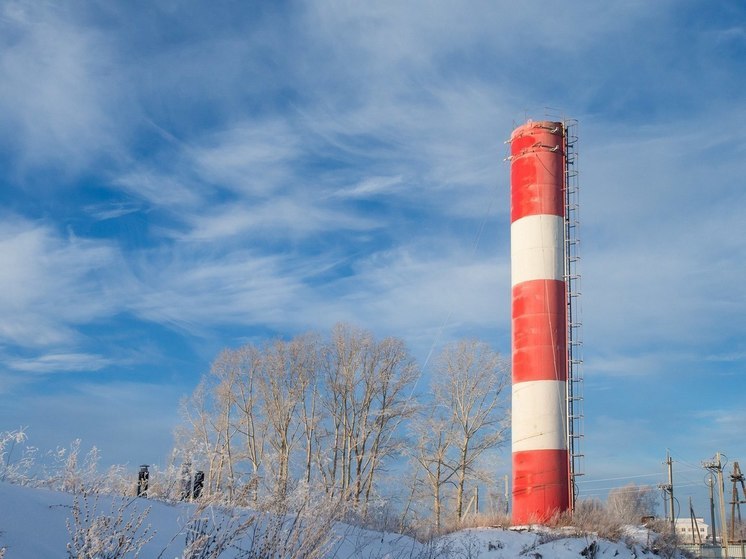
left=511, top=380, right=567, bottom=452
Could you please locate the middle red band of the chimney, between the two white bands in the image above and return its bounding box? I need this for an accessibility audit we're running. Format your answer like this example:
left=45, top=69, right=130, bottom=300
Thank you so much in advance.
left=512, top=280, right=567, bottom=384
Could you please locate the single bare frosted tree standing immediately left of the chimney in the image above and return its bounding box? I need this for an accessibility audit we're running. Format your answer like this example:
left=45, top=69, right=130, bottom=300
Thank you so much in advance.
left=433, top=340, right=509, bottom=520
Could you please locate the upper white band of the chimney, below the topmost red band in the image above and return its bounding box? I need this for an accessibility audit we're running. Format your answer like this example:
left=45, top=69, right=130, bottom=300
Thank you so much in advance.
left=510, top=214, right=565, bottom=285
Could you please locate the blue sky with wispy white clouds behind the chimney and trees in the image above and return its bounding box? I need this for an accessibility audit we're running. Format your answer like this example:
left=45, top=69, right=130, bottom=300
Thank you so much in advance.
left=0, top=0, right=746, bottom=512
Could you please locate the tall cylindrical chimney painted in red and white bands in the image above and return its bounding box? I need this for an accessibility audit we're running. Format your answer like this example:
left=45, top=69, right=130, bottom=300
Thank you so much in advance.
left=510, top=120, right=569, bottom=525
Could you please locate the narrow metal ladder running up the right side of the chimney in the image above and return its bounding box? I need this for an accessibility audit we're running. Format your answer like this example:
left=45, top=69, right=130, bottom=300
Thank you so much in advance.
left=563, top=119, right=585, bottom=510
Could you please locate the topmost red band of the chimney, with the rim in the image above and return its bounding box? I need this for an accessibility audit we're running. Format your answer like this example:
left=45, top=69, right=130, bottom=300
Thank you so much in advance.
left=510, top=123, right=565, bottom=223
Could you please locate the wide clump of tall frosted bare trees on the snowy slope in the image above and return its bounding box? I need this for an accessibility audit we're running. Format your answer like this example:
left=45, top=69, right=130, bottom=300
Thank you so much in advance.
left=178, top=325, right=418, bottom=508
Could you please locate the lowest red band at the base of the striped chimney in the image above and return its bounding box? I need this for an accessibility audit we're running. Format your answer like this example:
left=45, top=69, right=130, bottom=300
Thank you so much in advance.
left=513, top=450, right=570, bottom=524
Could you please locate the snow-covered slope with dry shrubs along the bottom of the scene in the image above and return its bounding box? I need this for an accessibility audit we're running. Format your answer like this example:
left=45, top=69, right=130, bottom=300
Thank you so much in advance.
left=0, top=483, right=678, bottom=559
